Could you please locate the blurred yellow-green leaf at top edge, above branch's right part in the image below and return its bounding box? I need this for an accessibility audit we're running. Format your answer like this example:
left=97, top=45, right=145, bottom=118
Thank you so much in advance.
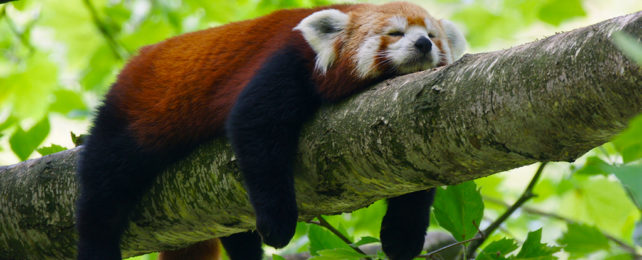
left=537, top=0, right=586, bottom=26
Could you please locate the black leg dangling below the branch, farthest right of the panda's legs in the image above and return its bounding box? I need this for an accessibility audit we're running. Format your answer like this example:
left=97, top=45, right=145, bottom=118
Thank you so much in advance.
left=380, top=188, right=435, bottom=260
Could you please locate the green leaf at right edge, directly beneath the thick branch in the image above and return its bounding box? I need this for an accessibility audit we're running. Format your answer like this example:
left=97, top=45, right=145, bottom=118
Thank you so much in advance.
left=613, top=114, right=642, bottom=163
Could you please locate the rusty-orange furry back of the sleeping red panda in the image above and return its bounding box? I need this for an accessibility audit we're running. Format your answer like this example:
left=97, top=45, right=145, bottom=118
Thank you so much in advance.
left=107, top=6, right=346, bottom=148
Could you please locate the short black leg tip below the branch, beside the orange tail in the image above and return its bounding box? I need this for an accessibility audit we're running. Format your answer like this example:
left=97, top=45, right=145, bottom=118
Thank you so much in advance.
left=221, top=231, right=263, bottom=260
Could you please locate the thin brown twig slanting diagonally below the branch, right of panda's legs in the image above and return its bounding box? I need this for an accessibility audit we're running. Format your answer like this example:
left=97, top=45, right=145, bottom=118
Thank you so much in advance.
left=466, top=162, right=548, bottom=255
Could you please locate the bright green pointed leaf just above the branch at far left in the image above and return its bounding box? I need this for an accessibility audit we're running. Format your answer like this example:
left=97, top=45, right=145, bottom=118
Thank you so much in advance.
left=9, top=117, right=49, bottom=161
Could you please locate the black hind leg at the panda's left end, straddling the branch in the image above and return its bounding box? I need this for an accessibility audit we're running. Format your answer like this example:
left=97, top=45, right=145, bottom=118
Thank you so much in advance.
left=76, top=104, right=169, bottom=260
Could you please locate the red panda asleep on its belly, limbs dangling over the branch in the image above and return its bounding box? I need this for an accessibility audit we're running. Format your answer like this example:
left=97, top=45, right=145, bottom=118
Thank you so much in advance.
left=76, top=3, right=465, bottom=260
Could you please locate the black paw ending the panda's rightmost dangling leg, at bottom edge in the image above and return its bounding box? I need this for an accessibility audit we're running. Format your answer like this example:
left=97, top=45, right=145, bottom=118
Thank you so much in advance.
left=380, top=227, right=426, bottom=260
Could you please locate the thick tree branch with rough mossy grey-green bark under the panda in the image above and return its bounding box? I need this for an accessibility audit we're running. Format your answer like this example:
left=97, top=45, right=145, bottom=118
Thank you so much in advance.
left=0, top=13, right=642, bottom=259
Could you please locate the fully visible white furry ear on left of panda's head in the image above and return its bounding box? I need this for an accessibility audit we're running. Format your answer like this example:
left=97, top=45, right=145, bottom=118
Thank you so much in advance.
left=294, top=9, right=350, bottom=73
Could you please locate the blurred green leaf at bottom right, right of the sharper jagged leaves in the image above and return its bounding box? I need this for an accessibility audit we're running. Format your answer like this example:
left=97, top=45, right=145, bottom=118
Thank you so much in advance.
left=557, top=224, right=609, bottom=257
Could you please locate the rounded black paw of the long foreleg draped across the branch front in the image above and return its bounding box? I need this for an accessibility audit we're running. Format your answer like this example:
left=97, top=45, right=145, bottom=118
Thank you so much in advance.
left=256, top=204, right=298, bottom=248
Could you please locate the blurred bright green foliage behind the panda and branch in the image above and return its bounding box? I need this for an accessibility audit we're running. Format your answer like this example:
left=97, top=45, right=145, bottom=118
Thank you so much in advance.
left=0, top=0, right=642, bottom=259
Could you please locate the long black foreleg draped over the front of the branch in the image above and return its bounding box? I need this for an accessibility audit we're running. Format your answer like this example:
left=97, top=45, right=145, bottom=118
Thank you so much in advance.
left=226, top=46, right=319, bottom=247
